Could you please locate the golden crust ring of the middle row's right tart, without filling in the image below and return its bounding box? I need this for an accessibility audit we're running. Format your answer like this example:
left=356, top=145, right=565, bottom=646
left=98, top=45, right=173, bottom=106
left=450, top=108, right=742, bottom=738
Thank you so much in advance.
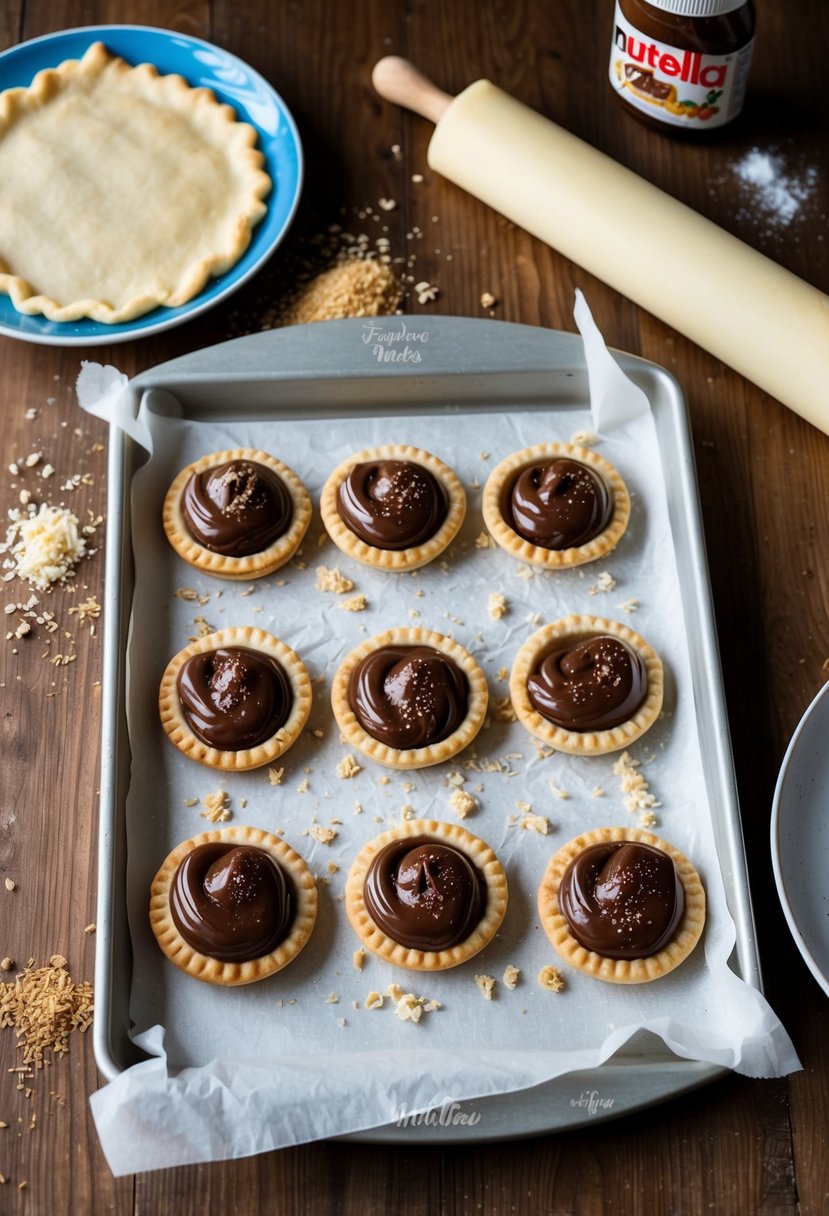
left=509, top=615, right=665, bottom=756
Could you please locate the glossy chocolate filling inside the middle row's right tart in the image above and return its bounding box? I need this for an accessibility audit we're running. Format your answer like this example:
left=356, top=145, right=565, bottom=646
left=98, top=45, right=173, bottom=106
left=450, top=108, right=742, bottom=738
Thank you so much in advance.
left=526, top=634, right=648, bottom=731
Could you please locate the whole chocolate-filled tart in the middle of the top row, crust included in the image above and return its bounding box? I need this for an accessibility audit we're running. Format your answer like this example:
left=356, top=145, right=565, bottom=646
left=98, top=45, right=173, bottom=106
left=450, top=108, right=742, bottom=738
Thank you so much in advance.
left=320, top=444, right=467, bottom=570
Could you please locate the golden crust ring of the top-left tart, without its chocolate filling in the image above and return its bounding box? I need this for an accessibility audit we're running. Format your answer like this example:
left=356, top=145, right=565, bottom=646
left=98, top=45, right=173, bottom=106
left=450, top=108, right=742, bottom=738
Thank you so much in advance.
left=162, top=447, right=311, bottom=581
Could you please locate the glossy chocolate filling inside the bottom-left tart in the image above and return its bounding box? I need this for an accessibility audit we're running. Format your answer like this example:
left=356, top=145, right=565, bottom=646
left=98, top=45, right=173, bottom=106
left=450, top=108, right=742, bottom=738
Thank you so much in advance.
left=170, top=840, right=295, bottom=963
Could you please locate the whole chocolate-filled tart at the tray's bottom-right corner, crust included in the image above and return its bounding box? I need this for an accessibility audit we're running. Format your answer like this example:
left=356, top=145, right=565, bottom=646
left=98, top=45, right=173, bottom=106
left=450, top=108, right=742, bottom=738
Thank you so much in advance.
left=538, top=828, right=705, bottom=984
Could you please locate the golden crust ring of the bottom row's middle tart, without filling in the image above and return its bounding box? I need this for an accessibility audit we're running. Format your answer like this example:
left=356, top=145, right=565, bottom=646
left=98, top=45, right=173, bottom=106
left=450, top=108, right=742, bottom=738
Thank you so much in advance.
left=345, top=820, right=507, bottom=972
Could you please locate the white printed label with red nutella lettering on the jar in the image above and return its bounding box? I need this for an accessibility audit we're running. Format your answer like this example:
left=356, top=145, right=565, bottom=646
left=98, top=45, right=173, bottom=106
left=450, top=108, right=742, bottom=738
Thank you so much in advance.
left=602, top=0, right=754, bottom=130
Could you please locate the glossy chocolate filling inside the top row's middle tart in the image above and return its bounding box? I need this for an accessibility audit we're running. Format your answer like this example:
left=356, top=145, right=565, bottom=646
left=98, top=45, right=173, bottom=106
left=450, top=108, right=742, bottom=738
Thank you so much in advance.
left=337, top=460, right=447, bottom=550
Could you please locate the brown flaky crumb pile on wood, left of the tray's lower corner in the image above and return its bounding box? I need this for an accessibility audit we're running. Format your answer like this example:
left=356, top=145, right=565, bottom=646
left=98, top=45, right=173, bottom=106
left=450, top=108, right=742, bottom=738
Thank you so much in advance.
left=0, top=955, right=92, bottom=1069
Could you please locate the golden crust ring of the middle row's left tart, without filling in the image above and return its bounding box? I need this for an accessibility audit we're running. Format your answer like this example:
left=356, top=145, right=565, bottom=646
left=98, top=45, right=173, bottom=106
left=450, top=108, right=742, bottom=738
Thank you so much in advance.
left=158, top=625, right=311, bottom=772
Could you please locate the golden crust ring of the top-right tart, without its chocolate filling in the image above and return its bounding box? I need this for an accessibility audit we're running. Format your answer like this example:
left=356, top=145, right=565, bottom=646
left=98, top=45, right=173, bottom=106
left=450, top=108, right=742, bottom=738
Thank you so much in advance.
left=481, top=444, right=631, bottom=570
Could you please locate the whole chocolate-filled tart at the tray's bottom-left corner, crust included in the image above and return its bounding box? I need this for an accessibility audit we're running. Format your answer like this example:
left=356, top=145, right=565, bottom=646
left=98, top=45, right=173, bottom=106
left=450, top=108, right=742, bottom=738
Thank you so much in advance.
left=150, top=827, right=317, bottom=986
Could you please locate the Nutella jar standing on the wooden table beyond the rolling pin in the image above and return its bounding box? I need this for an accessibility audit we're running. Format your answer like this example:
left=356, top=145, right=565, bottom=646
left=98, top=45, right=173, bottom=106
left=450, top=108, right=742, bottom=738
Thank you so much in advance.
left=610, top=0, right=755, bottom=134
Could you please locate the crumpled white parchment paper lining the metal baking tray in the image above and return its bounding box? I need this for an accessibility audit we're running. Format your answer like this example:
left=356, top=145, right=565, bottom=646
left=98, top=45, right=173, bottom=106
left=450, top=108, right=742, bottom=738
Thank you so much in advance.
left=80, top=296, right=800, bottom=1175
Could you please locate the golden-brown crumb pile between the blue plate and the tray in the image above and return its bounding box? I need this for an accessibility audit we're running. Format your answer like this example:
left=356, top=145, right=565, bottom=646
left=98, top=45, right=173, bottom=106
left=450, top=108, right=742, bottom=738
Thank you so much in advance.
left=282, top=258, right=404, bottom=325
